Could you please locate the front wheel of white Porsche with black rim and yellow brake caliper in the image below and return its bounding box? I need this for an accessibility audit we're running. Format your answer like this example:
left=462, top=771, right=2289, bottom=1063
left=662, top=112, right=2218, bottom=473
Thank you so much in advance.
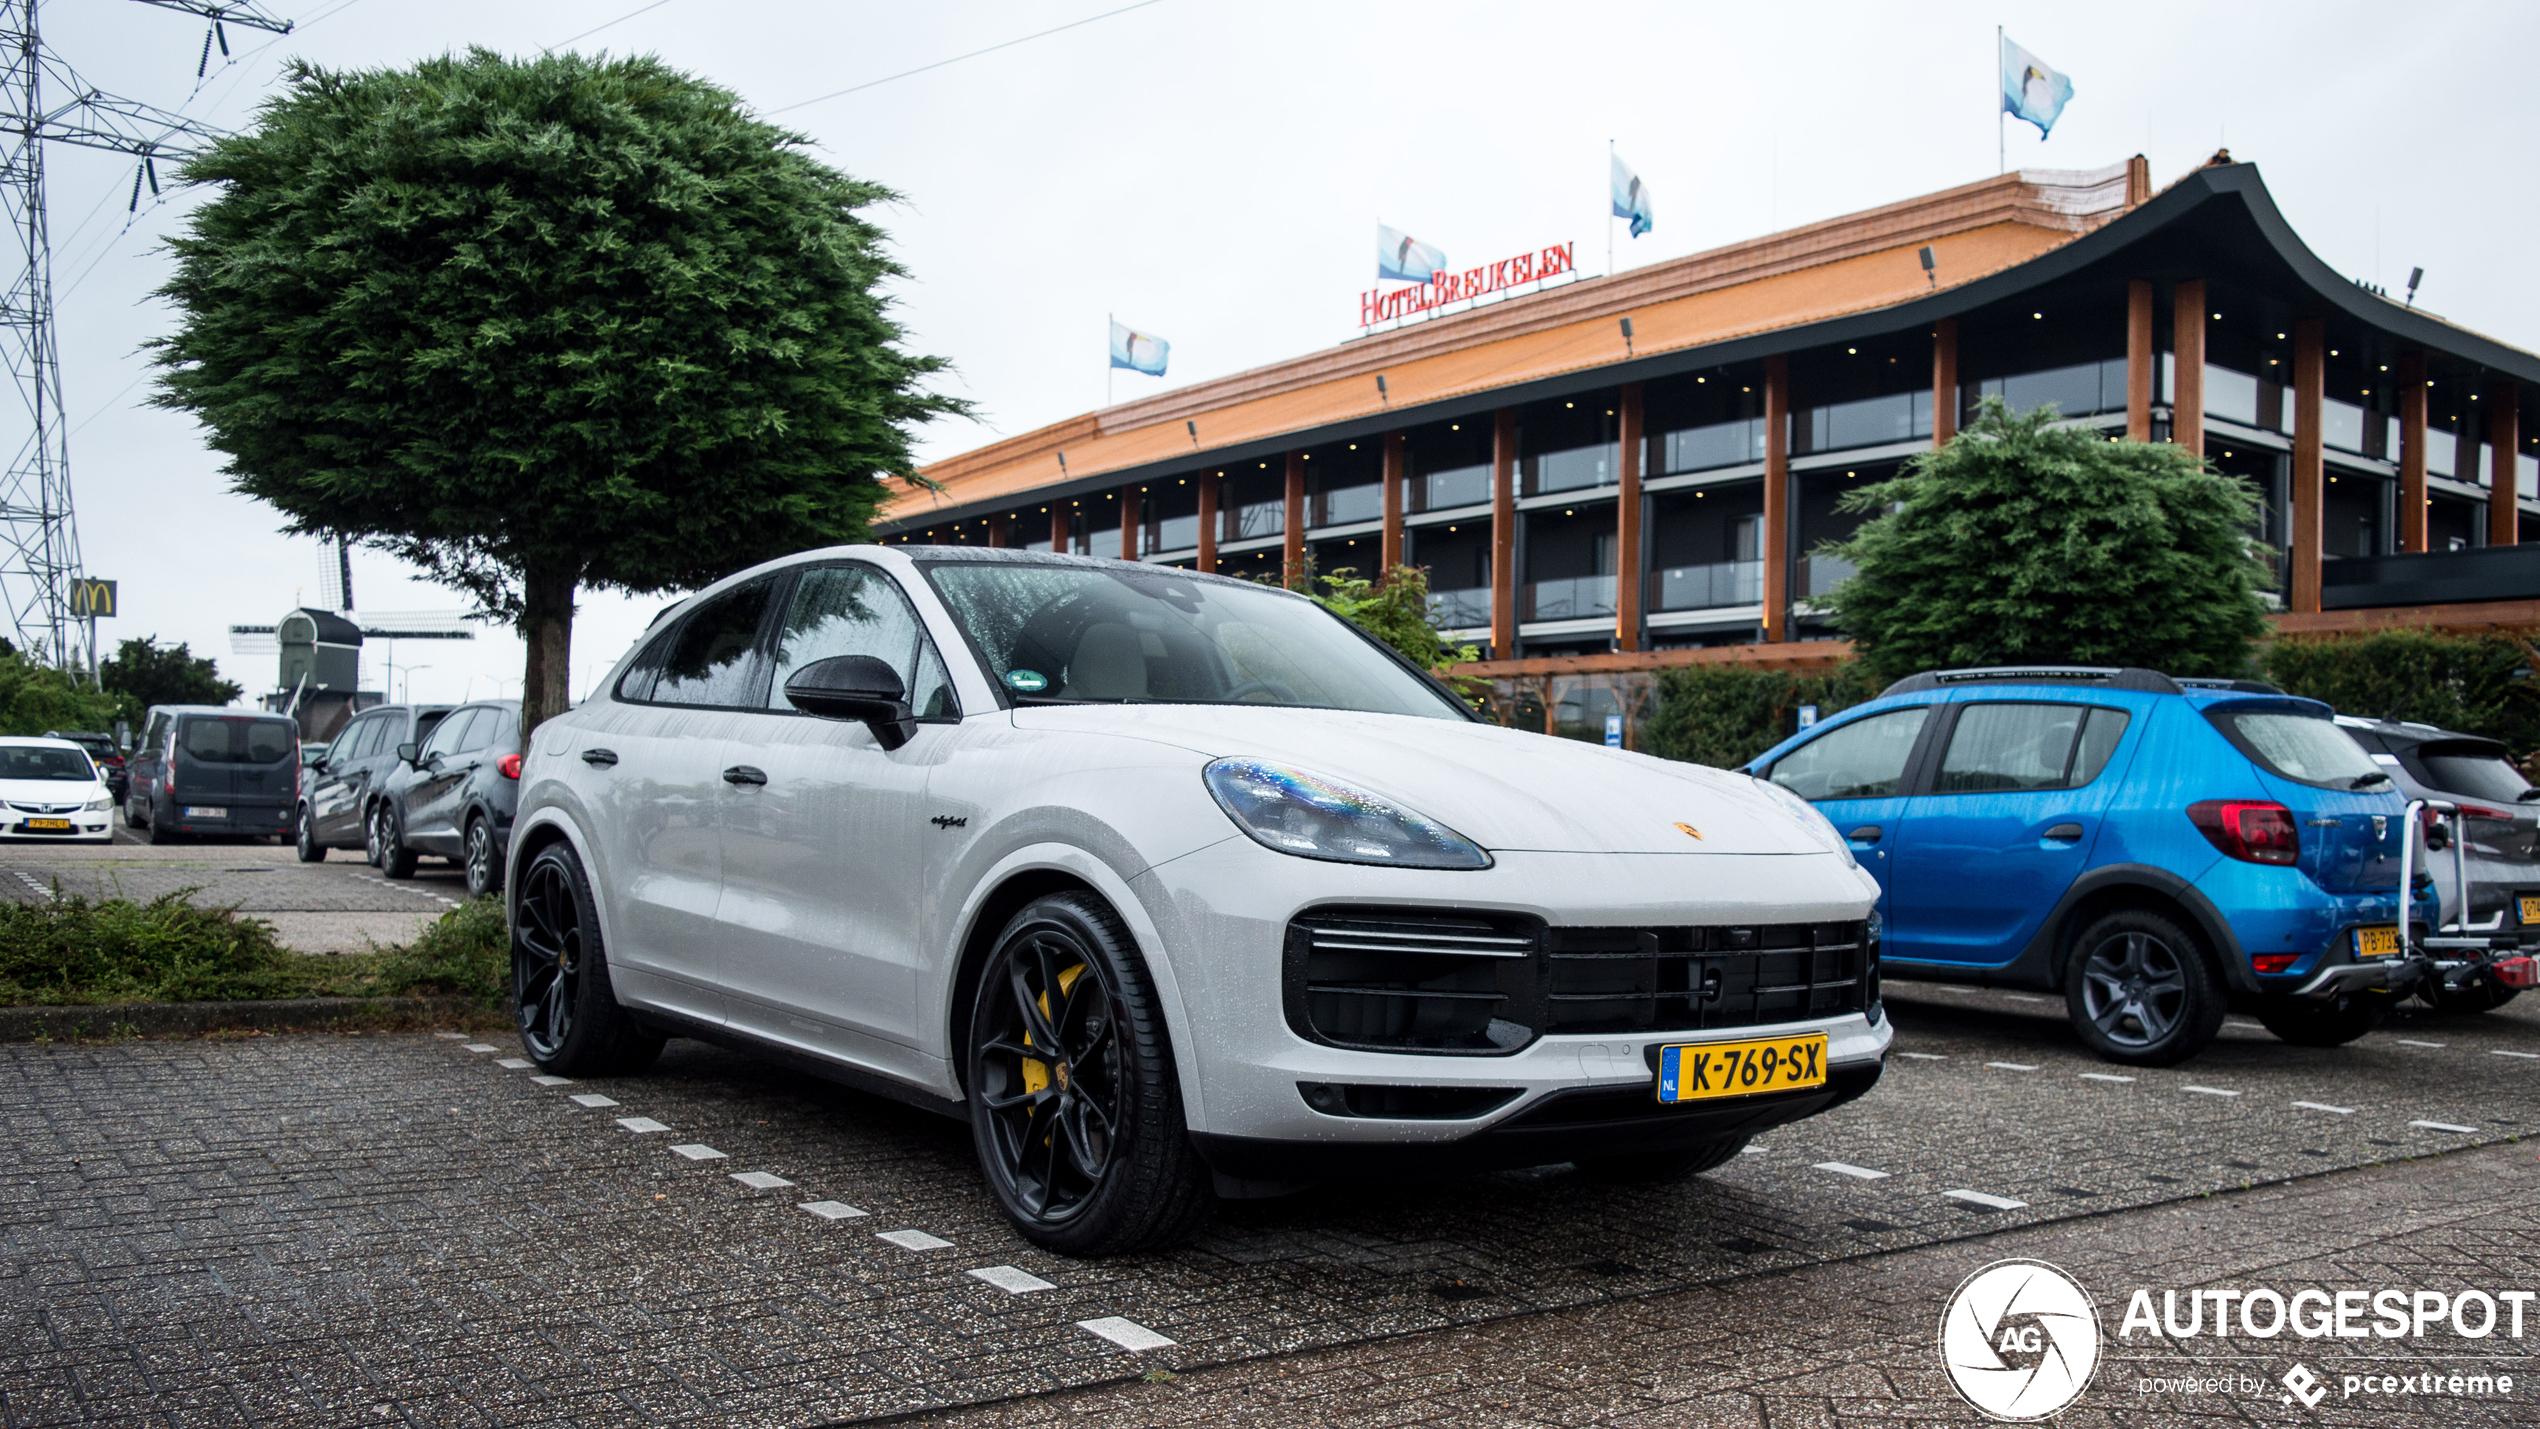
left=963, top=893, right=1217, bottom=1256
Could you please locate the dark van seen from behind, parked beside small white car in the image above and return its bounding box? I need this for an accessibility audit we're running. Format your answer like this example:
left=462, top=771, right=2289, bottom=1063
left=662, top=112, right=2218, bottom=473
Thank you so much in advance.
left=124, top=706, right=300, bottom=843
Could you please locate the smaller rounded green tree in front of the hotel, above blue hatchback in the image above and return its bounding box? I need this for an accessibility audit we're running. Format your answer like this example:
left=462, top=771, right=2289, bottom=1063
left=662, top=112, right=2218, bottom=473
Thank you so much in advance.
left=1829, top=398, right=2268, bottom=680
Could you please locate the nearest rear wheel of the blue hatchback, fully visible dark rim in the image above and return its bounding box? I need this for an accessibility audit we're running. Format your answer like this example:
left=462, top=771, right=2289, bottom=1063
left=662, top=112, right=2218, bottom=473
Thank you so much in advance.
left=2065, top=909, right=2228, bottom=1066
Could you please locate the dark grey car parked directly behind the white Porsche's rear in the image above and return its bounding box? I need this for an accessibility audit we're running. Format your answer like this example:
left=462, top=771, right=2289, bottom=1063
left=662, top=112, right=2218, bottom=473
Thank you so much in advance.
left=373, top=701, right=521, bottom=899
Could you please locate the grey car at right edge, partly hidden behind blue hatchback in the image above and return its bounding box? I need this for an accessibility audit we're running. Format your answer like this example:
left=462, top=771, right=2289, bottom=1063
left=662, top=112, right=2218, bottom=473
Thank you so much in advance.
left=2337, top=716, right=2540, bottom=1013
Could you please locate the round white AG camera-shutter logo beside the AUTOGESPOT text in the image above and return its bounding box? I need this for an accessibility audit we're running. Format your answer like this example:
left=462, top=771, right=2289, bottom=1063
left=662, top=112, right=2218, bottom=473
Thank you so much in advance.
left=1941, top=1261, right=2098, bottom=1421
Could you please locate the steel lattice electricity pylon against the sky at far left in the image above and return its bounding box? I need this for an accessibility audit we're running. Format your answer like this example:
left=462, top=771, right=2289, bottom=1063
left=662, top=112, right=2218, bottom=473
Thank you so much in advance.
left=0, top=0, right=292, bottom=673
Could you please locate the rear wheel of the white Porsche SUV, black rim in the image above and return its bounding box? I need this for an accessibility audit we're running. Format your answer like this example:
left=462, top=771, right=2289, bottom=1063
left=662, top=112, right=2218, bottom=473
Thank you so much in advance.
left=511, top=843, right=668, bottom=1076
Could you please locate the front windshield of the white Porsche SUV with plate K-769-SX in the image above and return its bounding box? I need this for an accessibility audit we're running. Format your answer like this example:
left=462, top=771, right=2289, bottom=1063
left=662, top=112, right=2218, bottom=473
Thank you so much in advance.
left=927, top=561, right=1468, bottom=718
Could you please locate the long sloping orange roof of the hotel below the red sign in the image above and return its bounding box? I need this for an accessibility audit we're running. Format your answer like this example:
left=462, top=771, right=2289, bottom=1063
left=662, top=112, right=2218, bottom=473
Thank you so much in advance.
left=881, top=155, right=2151, bottom=520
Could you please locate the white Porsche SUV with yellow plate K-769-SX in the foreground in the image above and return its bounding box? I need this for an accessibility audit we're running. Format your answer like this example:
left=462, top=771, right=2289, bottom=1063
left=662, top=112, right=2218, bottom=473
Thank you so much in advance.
left=508, top=546, right=1892, bottom=1254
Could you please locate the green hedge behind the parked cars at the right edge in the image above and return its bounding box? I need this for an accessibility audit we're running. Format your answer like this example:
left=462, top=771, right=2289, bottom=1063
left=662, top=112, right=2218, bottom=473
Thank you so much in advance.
left=2258, top=629, right=2540, bottom=759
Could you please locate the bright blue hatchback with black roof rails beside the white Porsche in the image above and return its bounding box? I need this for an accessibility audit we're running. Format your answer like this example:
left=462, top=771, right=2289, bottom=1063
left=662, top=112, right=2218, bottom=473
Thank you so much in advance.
left=1748, top=668, right=2433, bottom=1066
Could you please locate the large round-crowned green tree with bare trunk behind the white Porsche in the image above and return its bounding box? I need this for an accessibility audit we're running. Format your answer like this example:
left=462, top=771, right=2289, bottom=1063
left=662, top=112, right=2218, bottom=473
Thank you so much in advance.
left=155, top=51, right=965, bottom=741
